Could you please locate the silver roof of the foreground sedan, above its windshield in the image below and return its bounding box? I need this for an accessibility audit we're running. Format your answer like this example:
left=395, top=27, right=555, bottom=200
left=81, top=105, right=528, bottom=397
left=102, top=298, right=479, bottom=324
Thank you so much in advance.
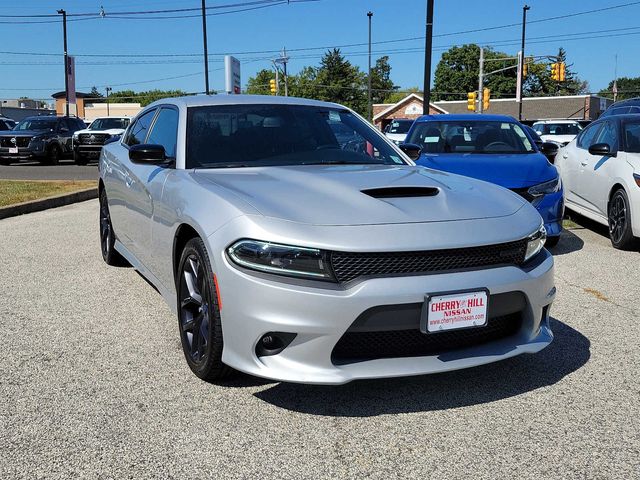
left=147, top=95, right=346, bottom=109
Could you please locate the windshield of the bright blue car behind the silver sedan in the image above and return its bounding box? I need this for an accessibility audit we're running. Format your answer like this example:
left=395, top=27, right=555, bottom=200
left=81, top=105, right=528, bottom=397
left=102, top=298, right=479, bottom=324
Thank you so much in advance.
left=407, top=120, right=535, bottom=154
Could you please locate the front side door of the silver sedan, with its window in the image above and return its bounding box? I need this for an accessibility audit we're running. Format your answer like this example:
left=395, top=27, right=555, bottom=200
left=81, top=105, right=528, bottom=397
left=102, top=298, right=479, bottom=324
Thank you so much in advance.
left=128, top=105, right=178, bottom=268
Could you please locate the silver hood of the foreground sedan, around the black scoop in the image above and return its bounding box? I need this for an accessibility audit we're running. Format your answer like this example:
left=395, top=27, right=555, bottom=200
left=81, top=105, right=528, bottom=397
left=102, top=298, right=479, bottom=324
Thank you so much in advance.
left=194, top=165, right=526, bottom=226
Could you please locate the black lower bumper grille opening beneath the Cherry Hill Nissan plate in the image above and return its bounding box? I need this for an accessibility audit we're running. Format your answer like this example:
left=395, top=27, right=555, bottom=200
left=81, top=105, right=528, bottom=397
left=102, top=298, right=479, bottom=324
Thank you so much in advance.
left=331, top=312, right=522, bottom=364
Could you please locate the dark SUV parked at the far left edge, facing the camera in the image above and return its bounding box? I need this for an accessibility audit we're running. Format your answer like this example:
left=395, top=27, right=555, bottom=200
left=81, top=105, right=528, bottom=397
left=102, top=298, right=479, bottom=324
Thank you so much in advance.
left=0, top=115, right=85, bottom=165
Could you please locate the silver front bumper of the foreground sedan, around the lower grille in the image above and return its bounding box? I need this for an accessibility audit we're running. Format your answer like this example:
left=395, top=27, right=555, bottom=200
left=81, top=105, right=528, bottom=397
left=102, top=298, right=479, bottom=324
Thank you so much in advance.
left=210, top=242, right=555, bottom=384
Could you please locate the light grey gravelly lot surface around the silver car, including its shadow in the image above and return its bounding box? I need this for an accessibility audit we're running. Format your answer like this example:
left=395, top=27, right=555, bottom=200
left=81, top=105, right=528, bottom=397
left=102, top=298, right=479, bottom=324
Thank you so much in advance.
left=0, top=201, right=640, bottom=479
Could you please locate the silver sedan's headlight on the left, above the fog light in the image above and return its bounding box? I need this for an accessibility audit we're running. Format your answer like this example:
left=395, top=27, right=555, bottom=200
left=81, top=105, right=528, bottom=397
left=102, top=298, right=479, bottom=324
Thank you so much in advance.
left=227, top=240, right=334, bottom=280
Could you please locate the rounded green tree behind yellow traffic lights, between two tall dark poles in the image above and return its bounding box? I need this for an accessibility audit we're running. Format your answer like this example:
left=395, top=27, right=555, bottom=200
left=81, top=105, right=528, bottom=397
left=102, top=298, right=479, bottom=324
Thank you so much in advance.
left=432, top=43, right=516, bottom=100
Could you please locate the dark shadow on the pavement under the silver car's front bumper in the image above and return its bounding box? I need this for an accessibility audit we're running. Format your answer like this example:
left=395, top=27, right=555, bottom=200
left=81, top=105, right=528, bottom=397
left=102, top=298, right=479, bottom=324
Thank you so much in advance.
left=254, top=318, right=590, bottom=417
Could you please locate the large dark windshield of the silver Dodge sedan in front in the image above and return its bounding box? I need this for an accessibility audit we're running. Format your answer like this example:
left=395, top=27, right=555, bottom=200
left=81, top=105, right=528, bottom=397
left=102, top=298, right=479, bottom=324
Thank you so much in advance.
left=187, top=105, right=404, bottom=168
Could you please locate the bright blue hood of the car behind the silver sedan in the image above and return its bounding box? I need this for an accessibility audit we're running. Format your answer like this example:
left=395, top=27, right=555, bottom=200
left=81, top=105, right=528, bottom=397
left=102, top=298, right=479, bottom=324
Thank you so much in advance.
left=416, top=153, right=557, bottom=188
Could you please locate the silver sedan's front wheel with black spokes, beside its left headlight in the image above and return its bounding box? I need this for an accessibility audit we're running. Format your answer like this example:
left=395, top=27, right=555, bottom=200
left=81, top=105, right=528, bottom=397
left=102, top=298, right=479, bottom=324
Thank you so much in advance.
left=176, top=237, right=231, bottom=381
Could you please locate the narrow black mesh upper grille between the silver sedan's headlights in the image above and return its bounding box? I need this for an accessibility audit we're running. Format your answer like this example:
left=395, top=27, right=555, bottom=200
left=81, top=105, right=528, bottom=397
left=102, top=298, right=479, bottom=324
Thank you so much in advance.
left=331, top=239, right=527, bottom=282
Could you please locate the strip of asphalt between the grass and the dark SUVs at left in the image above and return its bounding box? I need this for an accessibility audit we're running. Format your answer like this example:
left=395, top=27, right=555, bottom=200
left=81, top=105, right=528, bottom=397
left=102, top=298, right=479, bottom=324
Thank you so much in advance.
left=0, top=159, right=99, bottom=181
